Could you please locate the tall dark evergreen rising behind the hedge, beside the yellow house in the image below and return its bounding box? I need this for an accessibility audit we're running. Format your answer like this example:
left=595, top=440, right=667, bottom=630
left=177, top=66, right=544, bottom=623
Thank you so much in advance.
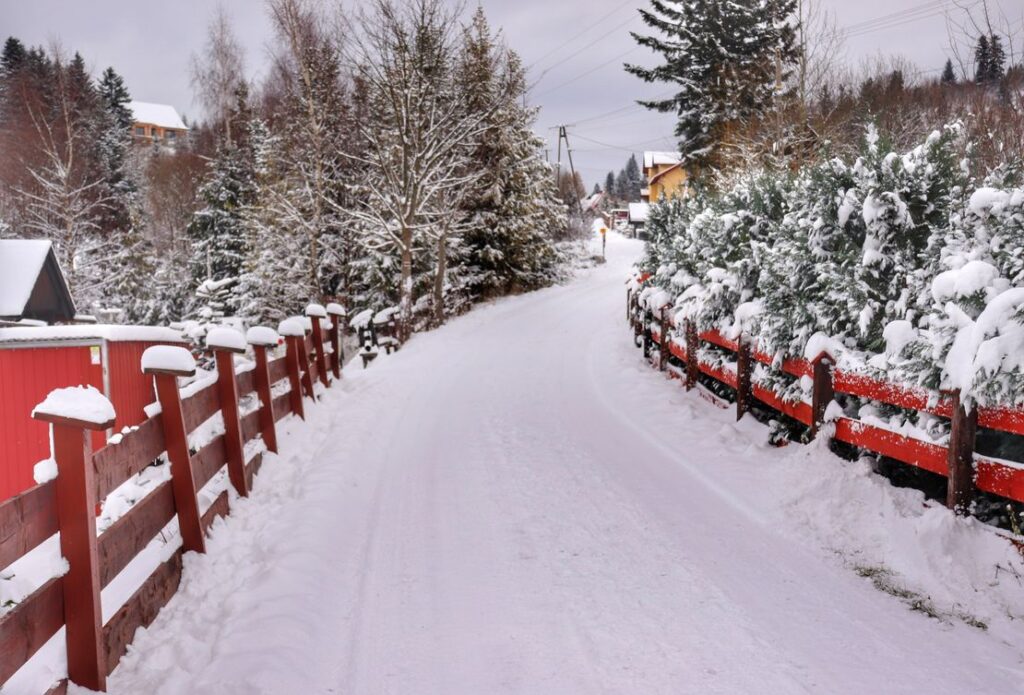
left=626, top=0, right=799, bottom=170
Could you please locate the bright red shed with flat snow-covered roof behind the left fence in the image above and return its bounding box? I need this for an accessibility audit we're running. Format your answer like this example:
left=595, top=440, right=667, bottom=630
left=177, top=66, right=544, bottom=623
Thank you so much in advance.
left=0, top=324, right=185, bottom=501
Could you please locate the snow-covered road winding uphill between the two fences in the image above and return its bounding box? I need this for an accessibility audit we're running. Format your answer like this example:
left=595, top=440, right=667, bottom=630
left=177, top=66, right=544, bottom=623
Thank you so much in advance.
left=111, top=238, right=1024, bottom=695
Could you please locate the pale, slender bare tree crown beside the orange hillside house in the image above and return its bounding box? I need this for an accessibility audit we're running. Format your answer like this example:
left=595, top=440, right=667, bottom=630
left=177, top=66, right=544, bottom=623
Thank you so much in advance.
left=191, top=5, right=245, bottom=143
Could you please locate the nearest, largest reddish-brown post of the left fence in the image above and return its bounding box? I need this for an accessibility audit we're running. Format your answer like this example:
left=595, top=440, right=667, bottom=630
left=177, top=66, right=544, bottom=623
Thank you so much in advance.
left=33, top=405, right=114, bottom=691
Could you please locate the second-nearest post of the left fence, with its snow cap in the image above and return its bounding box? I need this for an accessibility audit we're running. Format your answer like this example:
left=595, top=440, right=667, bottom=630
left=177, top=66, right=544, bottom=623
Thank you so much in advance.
left=142, top=354, right=206, bottom=553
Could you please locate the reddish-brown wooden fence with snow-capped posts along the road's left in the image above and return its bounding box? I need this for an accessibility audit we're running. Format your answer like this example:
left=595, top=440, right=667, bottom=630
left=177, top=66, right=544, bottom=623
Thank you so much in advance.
left=0, top=306, right=341, bottom=692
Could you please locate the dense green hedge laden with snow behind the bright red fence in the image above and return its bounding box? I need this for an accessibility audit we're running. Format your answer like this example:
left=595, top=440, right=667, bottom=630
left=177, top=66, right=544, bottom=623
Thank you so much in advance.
left=643, top=124, right=1024, bottom=405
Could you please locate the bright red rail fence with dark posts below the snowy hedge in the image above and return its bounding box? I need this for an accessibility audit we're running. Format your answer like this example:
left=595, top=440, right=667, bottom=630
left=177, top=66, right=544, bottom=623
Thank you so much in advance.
left=627, top=284, right=1024, bottom=513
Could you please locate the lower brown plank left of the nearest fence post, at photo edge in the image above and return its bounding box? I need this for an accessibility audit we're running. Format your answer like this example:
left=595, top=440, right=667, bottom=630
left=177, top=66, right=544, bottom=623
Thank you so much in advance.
left=0, top=577, right=63, bottom=685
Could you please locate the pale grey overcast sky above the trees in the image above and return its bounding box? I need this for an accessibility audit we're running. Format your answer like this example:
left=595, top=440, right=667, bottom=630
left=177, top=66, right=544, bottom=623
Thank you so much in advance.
left=0, top=0, right=1024, bottom=188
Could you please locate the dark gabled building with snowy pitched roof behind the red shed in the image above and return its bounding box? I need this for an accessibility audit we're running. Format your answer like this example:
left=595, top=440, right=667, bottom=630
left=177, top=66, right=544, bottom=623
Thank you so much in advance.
left=0, top=238, right=75, bottom=323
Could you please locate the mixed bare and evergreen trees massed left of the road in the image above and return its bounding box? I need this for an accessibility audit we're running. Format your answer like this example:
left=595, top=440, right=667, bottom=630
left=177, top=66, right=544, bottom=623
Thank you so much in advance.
left=0, top=0, right=568, bottom=331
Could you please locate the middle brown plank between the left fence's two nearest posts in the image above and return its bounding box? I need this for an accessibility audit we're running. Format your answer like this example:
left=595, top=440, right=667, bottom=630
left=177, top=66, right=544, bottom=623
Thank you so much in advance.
left=98, top=481, right=175, bottom=587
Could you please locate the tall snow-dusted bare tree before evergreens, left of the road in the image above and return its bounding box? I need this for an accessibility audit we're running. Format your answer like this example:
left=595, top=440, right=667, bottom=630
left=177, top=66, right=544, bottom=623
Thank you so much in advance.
left=349, top=0, right=488, bottom=335
